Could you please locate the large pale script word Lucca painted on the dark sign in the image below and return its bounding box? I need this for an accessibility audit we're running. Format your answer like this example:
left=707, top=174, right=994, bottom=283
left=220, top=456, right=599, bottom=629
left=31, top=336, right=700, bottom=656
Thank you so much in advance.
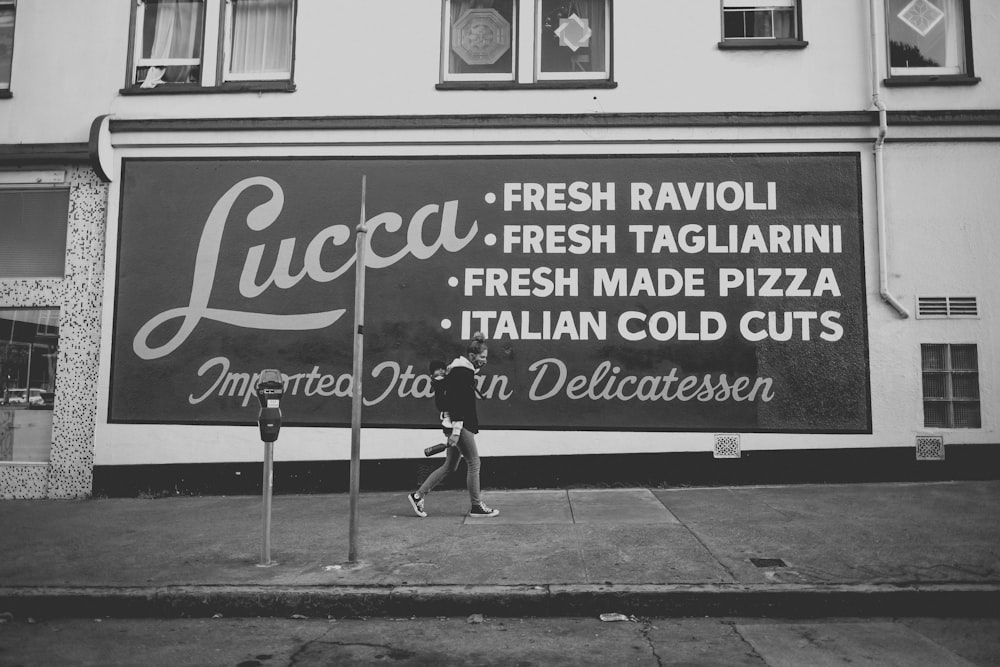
left=132, top=176, right=478, bottom=359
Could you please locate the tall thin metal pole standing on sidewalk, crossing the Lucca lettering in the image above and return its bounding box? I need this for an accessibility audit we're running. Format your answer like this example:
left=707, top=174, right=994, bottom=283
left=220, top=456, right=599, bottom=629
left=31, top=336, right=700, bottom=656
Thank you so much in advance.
left=347, top=175, right=368, bottom=563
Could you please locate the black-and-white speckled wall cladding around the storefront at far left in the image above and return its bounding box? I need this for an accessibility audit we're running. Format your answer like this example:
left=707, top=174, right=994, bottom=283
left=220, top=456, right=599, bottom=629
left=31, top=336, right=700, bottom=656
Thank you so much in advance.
left=0, top=166, right=108, bottom=498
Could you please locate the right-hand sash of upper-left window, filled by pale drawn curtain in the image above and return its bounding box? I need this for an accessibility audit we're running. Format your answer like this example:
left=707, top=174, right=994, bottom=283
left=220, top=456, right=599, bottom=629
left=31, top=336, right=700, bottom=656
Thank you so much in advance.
left=225, top=0, right=295, bottom=80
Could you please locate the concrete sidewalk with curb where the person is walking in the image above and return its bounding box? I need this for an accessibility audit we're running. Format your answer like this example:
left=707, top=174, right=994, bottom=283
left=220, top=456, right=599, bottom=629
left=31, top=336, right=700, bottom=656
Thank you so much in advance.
left=0, top=481, right=1000, bottom=617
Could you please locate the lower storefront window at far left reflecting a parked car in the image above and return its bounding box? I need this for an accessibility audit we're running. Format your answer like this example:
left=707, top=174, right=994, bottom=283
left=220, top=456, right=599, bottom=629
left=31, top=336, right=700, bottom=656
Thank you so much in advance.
left=0, top=308, right=59, bottom=462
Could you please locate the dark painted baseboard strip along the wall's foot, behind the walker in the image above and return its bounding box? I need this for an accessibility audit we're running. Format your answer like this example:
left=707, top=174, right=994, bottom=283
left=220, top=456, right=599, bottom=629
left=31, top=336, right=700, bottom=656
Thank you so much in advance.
left=93, top=444, right=1000, bottom=497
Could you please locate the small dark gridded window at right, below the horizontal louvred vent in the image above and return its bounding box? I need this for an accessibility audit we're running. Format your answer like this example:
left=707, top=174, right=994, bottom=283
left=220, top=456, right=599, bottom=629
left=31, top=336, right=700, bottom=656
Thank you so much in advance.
left=920, top=345, right=982, bottom=428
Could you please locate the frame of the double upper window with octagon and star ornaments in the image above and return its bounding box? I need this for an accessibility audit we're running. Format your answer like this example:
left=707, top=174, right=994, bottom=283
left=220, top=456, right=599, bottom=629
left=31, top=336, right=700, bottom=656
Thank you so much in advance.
left=437, top=0, right=617, bottom=90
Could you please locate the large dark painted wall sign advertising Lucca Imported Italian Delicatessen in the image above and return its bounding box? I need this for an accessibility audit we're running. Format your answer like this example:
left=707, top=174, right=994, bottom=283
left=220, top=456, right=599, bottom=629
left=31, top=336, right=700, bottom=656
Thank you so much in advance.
left=109, top=158, right=871, bottom=433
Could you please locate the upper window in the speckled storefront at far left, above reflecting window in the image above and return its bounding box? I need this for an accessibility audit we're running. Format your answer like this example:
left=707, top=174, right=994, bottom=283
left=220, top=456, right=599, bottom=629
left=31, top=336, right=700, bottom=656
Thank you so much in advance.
left=0, top=185, right=69, bottom=279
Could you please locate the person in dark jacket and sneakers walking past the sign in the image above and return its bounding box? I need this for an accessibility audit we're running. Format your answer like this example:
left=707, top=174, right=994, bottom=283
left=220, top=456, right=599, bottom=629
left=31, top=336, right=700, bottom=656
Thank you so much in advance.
left=407, top=331, right=500, bottom=517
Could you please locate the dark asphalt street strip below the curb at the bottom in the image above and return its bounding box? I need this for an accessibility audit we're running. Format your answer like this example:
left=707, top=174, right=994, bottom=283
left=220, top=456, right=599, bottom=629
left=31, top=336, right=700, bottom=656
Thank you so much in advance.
left=0, top=615, right=1000, bottom=667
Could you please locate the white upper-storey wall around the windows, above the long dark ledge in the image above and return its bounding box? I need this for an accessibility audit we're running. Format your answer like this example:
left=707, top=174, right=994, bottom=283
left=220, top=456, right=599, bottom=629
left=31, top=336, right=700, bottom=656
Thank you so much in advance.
left=7, top=0, right=1000, bottom=144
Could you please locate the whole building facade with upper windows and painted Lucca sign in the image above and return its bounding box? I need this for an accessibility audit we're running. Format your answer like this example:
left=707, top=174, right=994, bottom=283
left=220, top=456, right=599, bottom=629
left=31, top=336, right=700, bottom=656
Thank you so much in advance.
left=0, top=0, right=1000, bottom=498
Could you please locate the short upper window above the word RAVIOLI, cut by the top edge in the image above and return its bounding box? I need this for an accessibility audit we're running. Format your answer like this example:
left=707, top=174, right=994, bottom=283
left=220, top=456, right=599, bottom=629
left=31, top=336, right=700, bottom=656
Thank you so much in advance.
left=719, top=0, right=806, bottom=48
